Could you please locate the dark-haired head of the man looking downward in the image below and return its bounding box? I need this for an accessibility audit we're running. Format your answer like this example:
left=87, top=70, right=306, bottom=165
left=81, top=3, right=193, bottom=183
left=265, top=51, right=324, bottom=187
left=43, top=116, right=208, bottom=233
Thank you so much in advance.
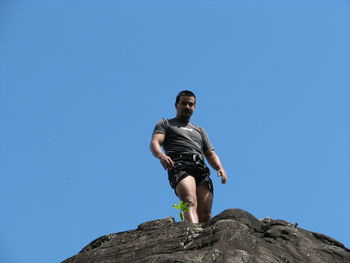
left=175, top=90, right=196, bottom=122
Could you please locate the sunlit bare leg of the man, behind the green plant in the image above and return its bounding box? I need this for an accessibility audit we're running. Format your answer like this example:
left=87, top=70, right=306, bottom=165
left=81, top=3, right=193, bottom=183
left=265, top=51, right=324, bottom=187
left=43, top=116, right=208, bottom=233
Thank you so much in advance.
left=176, top=175, right=198, bottom=223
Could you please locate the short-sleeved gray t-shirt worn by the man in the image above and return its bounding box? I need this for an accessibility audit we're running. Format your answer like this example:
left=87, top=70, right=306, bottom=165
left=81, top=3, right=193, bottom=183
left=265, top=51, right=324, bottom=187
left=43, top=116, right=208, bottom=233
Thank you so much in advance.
left=153, top=118, right=214, bottom=157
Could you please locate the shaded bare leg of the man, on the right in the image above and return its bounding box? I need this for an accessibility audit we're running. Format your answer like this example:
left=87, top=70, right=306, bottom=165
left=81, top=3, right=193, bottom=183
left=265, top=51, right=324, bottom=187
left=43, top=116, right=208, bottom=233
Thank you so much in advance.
left=197, top=184, right=213, bottom=223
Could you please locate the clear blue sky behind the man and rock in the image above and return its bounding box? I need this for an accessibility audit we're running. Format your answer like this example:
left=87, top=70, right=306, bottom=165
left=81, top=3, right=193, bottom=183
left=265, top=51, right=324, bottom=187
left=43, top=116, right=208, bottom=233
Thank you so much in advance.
left=0, top=0, right=350, bottom=263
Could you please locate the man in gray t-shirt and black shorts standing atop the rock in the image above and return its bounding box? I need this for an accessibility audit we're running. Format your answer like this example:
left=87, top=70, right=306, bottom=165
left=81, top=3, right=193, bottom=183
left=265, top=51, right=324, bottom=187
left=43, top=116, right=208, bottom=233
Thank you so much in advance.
left=150, top=90, right=227, bottom=223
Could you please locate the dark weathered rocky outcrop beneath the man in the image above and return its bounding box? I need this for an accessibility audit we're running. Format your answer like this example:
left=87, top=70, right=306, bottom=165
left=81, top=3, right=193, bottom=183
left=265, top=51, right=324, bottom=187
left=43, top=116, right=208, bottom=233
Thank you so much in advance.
left=63, top=209, right=350, bottom=263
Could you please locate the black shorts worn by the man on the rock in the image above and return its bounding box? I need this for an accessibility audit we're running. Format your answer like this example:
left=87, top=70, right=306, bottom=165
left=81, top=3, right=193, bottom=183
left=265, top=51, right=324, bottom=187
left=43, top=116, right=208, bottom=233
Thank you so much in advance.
left=168, top=154, right=214, bottom=195
